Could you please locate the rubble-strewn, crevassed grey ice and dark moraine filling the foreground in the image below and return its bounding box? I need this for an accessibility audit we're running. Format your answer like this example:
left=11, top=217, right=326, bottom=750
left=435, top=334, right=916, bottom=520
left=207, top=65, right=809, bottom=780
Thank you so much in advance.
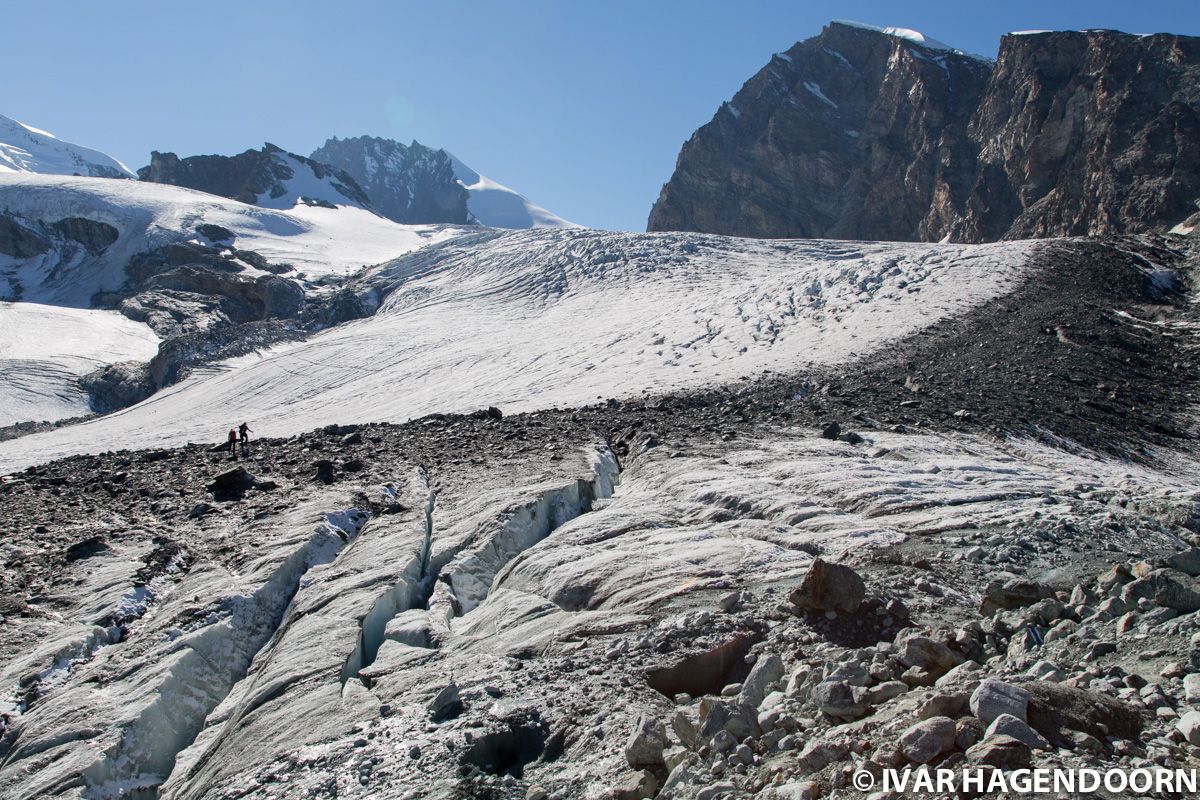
left=0, top=235, right=1200, bottom=800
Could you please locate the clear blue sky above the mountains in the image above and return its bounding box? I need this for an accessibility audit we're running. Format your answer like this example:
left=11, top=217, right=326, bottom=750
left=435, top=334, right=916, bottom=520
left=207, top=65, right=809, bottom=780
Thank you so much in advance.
left=0, top=0, right=1200, bottom=230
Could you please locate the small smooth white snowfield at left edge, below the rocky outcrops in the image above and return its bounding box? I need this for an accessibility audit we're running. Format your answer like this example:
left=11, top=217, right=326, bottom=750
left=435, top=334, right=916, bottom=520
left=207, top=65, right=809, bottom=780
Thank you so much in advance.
left=0, top=302, right=158, bottom=427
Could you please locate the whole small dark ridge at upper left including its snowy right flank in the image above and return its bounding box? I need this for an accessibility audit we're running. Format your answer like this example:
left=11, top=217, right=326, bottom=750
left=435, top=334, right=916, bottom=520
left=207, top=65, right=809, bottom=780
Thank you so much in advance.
left=138, top=143, right=371, bottom=209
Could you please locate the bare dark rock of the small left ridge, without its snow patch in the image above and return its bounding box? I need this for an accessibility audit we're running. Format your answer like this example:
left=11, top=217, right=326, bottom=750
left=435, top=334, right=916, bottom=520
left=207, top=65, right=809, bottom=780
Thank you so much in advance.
left=138, top=143, right=371, bottom=207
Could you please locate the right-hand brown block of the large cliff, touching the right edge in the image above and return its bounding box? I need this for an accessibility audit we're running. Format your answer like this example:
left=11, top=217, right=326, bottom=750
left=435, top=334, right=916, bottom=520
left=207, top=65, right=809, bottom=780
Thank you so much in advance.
left=943, top=31, right=1200, bottom=241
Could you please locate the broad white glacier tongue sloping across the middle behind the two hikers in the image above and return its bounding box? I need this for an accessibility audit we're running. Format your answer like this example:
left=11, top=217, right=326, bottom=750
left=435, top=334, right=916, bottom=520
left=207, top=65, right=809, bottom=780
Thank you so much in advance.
left=0, top=230, right=1033, bottom=470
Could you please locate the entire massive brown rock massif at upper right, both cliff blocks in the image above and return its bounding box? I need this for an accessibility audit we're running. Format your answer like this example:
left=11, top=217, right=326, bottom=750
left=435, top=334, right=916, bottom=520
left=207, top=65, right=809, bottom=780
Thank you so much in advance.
left=648, top=23, right=1200, bottom=242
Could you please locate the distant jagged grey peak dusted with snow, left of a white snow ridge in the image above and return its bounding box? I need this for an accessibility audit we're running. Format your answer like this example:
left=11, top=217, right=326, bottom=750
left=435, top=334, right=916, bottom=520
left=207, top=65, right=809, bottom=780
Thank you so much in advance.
left=311, top=136, right=472, bottom=224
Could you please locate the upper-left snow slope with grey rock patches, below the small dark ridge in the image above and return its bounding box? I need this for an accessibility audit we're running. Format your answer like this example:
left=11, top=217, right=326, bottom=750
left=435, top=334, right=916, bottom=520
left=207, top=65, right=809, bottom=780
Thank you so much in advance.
left=0, top=174, right=465, bottom=307
